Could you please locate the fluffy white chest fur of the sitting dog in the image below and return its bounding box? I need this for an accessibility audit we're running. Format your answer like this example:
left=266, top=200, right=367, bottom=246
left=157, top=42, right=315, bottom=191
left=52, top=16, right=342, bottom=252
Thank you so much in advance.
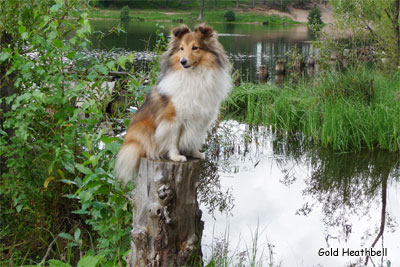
left=157, top=67, right=232, bottom=152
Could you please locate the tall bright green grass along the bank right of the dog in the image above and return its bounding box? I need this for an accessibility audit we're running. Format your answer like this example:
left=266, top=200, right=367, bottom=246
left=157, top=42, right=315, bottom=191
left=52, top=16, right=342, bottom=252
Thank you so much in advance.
left=225, top=67, right=400, bottom=151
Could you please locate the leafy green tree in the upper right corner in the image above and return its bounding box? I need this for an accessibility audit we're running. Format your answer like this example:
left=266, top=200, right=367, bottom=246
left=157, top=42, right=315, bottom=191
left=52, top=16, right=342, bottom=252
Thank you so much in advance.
left=330, top=0, right=400, bottom=66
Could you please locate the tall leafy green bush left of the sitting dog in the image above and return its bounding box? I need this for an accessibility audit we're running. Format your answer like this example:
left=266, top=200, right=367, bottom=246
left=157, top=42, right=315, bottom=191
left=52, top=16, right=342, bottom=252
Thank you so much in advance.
left=0, top=0, right=141, bottom=266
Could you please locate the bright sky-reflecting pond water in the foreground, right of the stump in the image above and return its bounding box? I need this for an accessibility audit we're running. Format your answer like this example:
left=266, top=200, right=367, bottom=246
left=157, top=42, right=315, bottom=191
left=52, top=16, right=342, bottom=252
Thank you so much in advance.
left=201, top=121, right=400, bottom=266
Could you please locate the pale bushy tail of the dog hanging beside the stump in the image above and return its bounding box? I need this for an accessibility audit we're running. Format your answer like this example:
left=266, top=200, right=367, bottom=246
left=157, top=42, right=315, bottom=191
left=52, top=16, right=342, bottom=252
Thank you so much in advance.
left=114, top=141, right=144, bottom=184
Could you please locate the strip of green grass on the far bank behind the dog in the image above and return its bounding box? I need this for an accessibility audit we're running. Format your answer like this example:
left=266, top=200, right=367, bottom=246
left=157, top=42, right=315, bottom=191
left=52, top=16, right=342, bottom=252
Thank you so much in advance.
left=89, top=8, right=297, bottom=25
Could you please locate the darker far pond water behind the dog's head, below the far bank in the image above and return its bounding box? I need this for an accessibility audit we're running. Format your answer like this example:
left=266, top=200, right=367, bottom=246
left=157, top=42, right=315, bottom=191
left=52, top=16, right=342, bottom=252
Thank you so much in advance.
left=91, top=20, right=314, bottom=82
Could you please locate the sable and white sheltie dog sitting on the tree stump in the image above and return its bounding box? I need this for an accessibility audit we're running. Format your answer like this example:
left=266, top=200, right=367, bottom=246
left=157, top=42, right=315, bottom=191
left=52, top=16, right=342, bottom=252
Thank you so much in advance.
left=115, top=25, right=232, bottom=183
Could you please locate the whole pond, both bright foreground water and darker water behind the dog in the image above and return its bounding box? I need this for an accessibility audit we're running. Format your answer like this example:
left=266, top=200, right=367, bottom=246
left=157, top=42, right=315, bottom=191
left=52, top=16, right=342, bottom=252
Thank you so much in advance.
left=92, top=21, right=400, bottom=266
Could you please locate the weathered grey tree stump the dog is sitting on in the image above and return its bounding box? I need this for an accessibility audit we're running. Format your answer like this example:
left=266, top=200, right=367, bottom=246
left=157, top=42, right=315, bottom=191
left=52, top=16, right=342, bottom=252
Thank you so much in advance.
left=128, top=158, right=204, bottom=267
